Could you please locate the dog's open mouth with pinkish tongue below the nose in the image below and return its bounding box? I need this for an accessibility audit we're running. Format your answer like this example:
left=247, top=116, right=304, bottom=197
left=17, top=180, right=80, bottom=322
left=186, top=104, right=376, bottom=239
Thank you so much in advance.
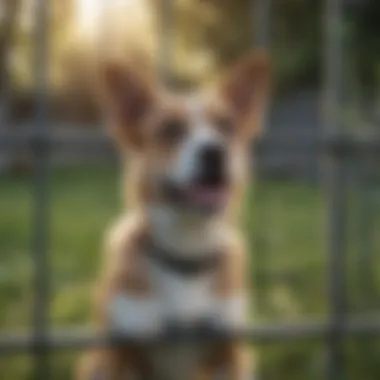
left=165, top=183, right=229, bottom=211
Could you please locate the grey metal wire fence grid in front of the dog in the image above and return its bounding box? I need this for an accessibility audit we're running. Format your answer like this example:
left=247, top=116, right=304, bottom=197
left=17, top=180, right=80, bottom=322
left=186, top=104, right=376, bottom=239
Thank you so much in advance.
left=0, top=0, right=380, bottom=380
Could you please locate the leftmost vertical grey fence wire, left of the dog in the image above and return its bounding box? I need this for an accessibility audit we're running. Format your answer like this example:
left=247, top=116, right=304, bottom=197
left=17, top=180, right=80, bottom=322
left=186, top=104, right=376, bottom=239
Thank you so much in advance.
left=32, top=0, right=50, bottom=380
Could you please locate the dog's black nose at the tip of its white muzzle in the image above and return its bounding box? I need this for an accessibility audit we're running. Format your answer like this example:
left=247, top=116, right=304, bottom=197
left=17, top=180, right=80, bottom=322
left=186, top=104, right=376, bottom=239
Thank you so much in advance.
left=200, top=145, right=226, bottom=186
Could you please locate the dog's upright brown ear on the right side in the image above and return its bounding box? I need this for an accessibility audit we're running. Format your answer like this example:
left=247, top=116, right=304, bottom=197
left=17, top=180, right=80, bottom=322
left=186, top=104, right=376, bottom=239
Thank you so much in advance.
left=221, top=51, right=271, bottom=138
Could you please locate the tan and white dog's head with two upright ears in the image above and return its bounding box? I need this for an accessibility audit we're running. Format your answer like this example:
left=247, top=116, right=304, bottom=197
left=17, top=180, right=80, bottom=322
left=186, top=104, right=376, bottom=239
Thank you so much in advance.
left=103, top=52, right=269, bottom=214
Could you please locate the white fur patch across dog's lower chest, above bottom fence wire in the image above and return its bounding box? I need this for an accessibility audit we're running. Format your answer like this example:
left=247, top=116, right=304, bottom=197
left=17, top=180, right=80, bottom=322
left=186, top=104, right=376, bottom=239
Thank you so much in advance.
left=109, top=265, right=247, bottom=330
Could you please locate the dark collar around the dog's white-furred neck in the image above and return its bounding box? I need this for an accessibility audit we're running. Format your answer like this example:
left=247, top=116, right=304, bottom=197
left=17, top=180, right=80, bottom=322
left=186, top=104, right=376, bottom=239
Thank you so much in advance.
left=143, top=238, right=222, bottom=277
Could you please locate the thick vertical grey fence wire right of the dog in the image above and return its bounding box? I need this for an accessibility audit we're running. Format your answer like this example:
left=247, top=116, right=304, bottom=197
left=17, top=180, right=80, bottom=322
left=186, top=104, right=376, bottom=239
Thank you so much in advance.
left=323, top=0, right=346, bottom=380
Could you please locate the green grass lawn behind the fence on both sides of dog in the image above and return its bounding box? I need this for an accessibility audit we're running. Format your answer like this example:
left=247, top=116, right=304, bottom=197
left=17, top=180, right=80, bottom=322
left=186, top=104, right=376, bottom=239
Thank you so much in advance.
left=0, top=166, right=380, bottom=380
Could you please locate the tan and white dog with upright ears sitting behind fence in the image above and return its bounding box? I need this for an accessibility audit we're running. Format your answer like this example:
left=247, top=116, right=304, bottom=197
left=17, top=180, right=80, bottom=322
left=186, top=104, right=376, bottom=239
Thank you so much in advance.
left=78, top=51, right=271, bottom=380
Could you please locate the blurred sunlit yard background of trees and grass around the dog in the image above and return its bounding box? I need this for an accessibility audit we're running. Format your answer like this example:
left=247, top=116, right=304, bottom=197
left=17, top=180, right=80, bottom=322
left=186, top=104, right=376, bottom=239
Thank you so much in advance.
left=0, top=0, right=380, bottom=380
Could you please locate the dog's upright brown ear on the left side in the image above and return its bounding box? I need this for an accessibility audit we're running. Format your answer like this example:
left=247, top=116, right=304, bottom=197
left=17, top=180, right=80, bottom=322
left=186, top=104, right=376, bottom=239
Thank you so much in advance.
left=101, top=62, right=155, bottom=149
